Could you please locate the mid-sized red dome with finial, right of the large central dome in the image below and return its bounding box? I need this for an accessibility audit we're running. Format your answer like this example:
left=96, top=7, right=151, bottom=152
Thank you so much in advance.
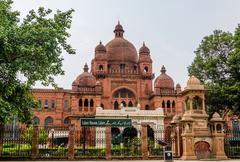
left=154, top=66, right=174, bottom=89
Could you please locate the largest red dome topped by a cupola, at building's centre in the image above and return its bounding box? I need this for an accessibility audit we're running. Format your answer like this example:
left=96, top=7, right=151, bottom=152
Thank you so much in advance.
left=106, top=22, right=138, bottom=63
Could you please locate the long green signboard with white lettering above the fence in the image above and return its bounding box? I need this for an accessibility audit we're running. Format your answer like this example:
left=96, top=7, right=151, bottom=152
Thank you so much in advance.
left=81, top=118, right=132, bottom=127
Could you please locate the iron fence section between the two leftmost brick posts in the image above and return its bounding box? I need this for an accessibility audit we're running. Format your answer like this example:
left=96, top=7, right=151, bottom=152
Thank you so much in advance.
left=38, top=126, right=69, bottom=158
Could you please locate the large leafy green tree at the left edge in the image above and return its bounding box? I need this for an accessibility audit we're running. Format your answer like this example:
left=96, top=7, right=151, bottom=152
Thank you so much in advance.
left=0, top=0, right=75, bottom=124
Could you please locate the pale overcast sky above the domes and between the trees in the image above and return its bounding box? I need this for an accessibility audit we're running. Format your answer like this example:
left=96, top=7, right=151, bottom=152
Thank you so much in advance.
left=12, top=0, right=240, bottom=89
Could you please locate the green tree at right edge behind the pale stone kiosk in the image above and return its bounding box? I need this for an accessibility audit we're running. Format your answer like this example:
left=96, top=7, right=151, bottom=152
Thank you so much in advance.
left=188, top=25, right=240, bottom=114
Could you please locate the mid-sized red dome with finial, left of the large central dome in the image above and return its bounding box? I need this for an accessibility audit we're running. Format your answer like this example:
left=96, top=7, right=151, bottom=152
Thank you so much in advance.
left=72, top=64, right=96, bottom=87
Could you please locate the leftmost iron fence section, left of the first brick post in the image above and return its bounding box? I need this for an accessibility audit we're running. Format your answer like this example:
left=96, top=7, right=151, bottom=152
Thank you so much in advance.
left=0, top=126, right=33, bottom=158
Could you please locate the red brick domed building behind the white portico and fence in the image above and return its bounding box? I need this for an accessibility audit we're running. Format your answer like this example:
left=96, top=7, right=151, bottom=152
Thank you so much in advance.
left=33, top=23, right=182, bottom=126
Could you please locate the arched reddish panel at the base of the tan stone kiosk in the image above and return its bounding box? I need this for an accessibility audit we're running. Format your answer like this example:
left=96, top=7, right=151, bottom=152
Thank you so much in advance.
left=194, top=141, right=211, bottom=159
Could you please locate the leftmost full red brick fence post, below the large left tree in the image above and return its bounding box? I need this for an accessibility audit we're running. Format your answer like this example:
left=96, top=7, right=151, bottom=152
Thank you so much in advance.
left=31, top=125, right=39, bottom=160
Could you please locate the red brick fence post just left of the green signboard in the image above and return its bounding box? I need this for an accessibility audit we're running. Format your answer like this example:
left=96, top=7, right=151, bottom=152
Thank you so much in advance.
left=68, top=124, right=75, bottom=160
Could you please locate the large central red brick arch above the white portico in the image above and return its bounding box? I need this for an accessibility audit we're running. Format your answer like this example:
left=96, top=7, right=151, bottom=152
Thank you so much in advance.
left=112, top=88, right=136, bottom=109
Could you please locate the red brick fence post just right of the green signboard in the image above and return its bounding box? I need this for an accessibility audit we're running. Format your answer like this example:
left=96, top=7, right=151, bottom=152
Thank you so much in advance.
left=141, top=124, right=148, bottom=159
